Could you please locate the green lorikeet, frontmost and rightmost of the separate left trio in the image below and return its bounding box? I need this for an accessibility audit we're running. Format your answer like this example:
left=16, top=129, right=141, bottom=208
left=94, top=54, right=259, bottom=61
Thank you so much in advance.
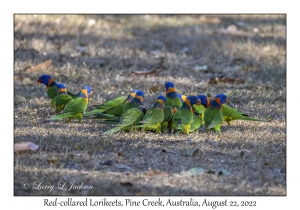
left=50, top=86, right=93, bottom=123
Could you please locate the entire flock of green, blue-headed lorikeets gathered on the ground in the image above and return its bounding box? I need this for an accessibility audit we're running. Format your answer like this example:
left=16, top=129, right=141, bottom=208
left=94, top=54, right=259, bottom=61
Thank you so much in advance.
left=37, top=74, right=267, bottom=135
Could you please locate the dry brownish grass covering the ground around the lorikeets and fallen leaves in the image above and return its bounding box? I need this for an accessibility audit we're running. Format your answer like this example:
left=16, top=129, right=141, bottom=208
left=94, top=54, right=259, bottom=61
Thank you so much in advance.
left=14, top=15, right=286, bottom=195
